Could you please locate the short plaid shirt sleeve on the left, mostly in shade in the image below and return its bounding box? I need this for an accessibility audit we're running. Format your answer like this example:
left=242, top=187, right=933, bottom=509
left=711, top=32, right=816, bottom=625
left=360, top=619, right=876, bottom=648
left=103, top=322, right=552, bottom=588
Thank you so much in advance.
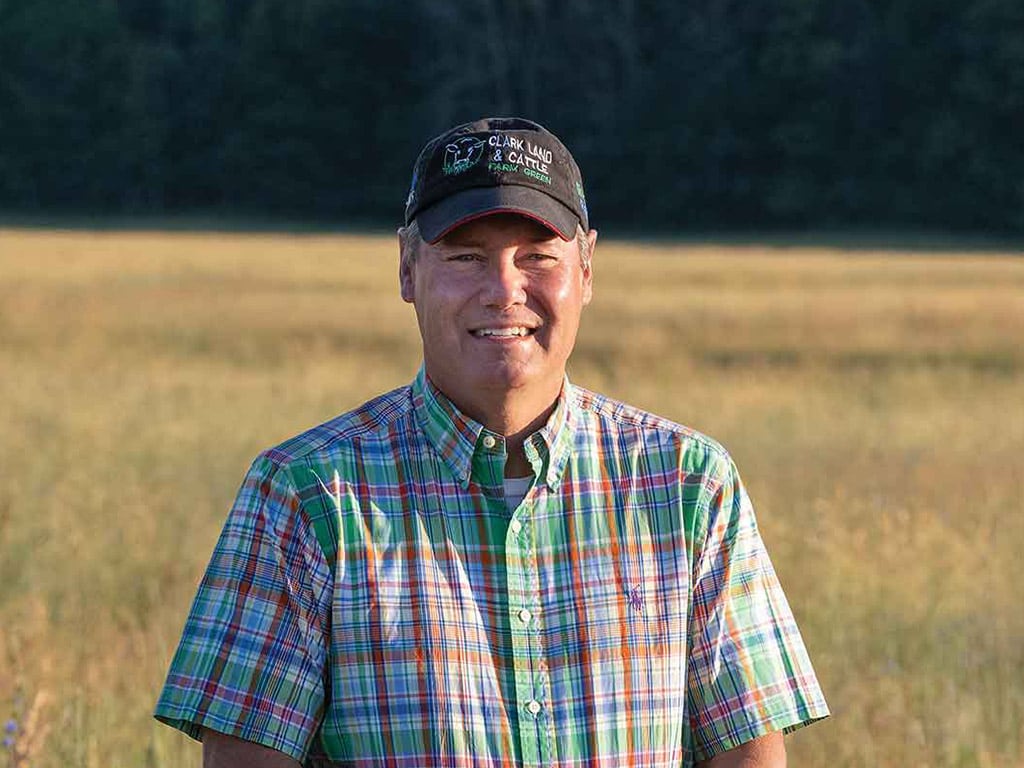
left=154, top=455, right=331, bottom=762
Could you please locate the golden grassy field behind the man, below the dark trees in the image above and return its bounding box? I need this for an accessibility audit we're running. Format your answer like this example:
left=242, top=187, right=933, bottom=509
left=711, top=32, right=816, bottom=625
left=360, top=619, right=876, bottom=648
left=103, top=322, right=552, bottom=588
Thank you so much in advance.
left=0, top=229, right=1024, bottom=768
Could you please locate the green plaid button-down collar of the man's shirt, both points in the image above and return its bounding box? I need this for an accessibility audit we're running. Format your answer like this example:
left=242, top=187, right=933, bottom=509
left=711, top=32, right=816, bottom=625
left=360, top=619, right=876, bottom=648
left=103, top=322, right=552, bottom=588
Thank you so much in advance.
left=412, top=367, right=578, bottom=490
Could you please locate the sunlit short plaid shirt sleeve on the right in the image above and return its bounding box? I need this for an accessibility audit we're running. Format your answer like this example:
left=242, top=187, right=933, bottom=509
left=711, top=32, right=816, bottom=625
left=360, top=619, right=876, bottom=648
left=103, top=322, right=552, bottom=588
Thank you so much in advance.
left=687, top=455, right=828, bottom=760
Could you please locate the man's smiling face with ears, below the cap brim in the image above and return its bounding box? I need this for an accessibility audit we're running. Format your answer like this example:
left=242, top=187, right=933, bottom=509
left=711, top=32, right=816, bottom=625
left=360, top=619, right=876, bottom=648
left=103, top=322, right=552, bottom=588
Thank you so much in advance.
left=400, top=214, right=597, bottom=417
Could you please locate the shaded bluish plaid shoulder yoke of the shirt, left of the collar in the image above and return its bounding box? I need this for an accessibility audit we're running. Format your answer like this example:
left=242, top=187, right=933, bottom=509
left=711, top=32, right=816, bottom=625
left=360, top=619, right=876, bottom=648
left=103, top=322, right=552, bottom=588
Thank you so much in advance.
left=260, top=385, right=413, bottom=466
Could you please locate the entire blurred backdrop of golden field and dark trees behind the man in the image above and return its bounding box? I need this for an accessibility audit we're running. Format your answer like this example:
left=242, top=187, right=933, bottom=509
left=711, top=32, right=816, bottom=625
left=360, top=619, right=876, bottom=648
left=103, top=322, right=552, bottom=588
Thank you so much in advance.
left=0, top=0, right=1024, bottom=768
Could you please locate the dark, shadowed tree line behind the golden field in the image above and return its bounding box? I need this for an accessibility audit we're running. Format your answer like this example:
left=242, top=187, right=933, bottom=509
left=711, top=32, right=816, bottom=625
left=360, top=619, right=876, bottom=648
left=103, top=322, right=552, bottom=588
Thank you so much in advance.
left=0, top=0, right=1024, bottom=231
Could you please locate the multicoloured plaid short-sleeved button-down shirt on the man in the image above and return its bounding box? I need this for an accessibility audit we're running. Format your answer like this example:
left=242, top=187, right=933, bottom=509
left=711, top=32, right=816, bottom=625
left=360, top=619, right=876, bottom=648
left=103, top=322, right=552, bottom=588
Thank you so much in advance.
left=156, top=371, right=828, bottom=768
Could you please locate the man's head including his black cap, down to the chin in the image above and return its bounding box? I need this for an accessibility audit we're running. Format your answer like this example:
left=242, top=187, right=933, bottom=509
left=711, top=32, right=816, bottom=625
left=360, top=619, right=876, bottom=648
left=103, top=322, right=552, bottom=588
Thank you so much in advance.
left=399, top=118, right=597, bottom=418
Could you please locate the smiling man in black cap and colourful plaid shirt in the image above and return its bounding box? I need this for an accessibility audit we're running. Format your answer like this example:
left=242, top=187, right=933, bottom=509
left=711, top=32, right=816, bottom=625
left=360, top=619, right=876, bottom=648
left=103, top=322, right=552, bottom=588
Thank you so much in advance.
left=156, top=119, right=828, bottom=768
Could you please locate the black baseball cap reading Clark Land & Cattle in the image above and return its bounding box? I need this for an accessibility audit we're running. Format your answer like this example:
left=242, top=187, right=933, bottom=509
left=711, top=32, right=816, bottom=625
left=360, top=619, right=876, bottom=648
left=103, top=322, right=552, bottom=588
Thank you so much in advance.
left=406, top=118, right=590, bottom=243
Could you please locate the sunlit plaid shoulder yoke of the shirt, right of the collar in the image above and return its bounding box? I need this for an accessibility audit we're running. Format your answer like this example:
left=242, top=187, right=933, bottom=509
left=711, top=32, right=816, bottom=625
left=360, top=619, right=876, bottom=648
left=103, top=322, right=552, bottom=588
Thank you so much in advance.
left=572, top=384, right=731, bottom=462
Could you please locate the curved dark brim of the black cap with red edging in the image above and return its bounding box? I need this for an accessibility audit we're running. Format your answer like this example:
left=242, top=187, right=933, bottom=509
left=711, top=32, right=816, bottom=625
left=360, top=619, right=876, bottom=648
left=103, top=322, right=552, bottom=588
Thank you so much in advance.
left=416, top=184, right=580, bottom=243
